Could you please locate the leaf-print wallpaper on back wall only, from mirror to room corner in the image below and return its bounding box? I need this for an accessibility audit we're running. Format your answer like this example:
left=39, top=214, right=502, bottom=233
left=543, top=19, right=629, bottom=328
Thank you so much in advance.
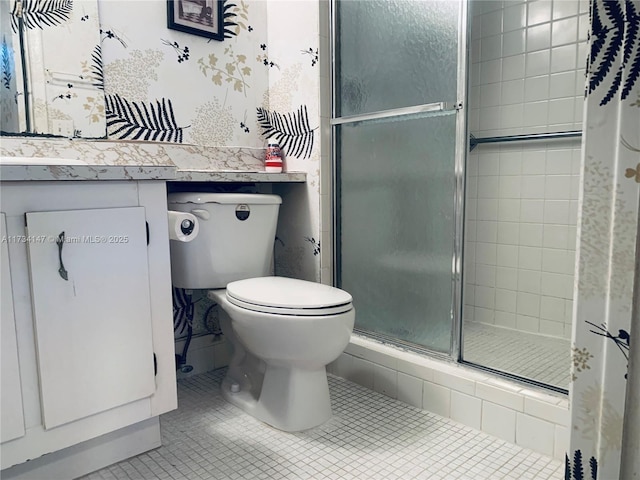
left=99, top=0, right=269, bottom=148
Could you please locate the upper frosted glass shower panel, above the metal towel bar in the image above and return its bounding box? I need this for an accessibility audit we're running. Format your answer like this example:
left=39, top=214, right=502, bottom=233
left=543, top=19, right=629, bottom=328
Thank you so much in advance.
left=335, top=0, right=461, bottom=117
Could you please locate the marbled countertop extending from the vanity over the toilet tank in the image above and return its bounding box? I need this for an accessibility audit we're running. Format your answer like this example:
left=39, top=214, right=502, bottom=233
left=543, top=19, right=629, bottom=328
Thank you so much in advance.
left=0, top=165, right=307, bottom=182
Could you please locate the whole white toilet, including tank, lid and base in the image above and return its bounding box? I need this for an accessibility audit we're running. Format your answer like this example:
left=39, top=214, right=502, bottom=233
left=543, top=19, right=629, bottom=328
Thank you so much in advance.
left=169, top=193, right=355, bottom=432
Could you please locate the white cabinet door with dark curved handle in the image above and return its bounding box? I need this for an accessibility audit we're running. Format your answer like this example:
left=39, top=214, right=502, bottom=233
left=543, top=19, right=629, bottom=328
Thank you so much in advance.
left=26, top=207, right=155, bottom=429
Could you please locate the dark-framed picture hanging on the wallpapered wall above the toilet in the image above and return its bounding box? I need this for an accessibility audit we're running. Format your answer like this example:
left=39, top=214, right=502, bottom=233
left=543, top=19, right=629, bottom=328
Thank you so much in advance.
left=167, top=0, right=224, bottom=41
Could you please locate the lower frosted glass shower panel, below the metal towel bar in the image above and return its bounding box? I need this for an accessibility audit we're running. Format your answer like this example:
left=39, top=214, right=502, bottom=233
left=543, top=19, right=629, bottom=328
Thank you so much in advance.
left=336, top=111, right=456, bottom=353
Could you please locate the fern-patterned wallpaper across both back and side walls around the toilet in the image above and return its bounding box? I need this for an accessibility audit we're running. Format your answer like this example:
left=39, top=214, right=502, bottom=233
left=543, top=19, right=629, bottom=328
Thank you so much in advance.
left=99, top=0, right=320, bottom=281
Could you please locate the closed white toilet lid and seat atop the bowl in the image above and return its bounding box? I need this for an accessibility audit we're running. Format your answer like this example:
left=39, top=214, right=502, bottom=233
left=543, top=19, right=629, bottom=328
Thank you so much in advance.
left=227, top=277, right=353, bottom=315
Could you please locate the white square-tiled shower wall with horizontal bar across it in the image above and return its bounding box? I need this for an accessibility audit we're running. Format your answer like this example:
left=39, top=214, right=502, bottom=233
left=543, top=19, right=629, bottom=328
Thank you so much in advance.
left=464, top=0, right=588, bottom=338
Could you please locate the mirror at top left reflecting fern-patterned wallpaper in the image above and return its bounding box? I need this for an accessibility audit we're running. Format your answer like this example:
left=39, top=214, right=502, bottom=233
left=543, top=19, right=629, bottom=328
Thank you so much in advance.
left=0, top=0, right=106, bottom=138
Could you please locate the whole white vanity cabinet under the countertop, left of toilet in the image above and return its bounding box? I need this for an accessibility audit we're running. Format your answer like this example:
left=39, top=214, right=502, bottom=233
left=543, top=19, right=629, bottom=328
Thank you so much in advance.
left=0, top=180, right=177, bottom=478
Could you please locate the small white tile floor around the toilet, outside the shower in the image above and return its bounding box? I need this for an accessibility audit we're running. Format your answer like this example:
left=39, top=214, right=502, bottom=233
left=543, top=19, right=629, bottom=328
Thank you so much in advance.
left=83, top=370, right=563, bottom=480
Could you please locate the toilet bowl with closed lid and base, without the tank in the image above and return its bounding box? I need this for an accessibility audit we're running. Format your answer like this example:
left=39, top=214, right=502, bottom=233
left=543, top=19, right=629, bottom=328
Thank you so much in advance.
left=209, top=277, right=355, bottom=432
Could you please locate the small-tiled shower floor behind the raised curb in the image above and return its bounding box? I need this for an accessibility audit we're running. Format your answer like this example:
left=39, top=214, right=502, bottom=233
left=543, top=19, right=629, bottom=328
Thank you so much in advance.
left=463, top=321, right=571, bottom=389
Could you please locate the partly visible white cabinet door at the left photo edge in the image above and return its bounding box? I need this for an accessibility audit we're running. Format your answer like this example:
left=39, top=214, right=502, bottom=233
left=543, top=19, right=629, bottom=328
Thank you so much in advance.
left=0, top=213, right=24, bottom=442
